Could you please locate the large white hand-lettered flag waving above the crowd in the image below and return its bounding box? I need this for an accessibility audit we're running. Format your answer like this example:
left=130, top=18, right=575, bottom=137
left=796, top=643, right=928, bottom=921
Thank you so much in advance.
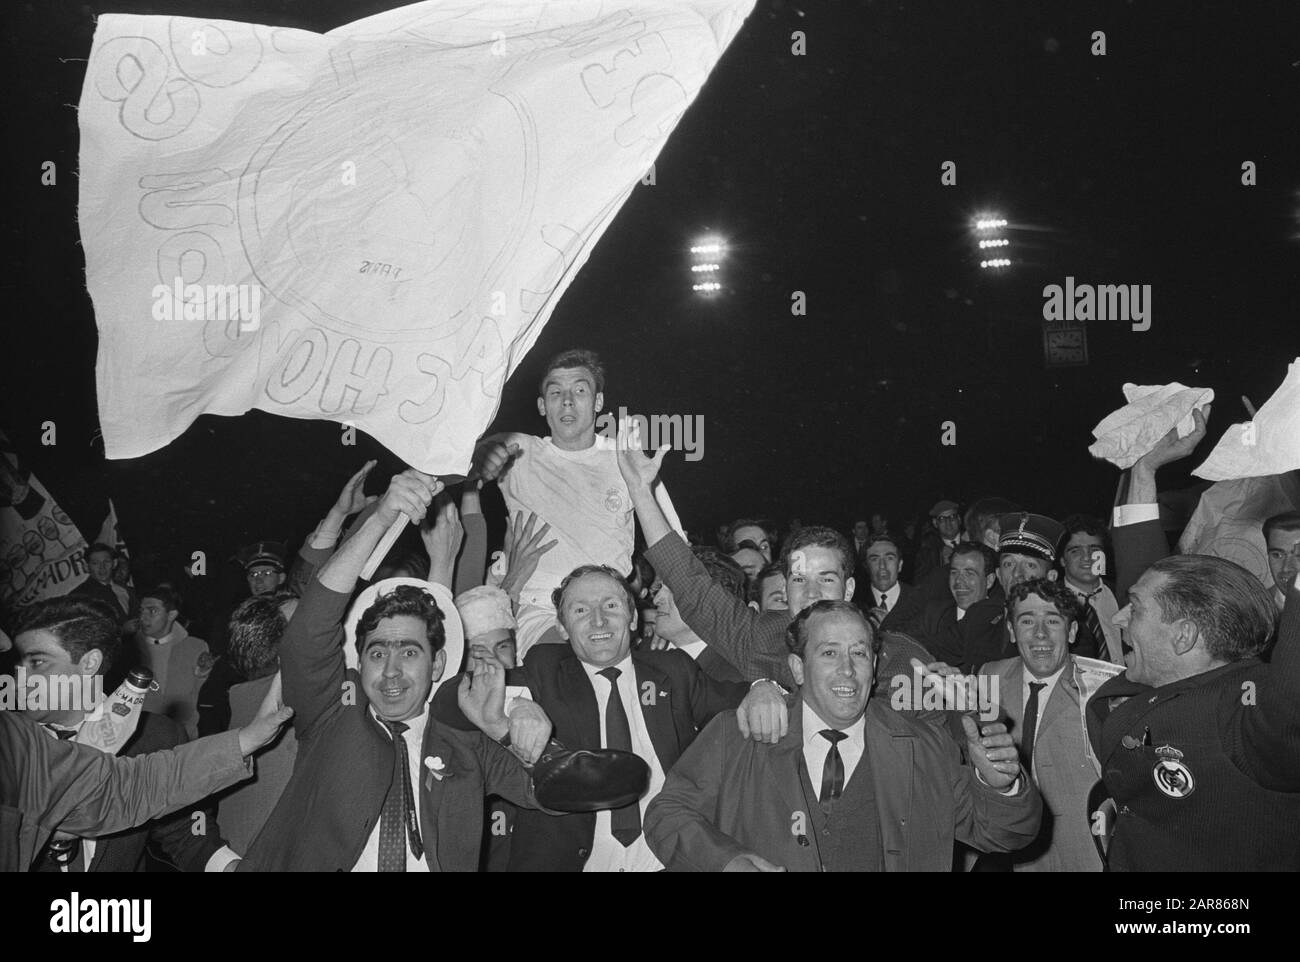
left=78, top=0, right=754, bottom=473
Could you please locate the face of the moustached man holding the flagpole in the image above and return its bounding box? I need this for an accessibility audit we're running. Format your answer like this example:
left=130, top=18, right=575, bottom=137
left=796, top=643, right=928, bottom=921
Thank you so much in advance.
left=359, top=615, right=447, bottom=722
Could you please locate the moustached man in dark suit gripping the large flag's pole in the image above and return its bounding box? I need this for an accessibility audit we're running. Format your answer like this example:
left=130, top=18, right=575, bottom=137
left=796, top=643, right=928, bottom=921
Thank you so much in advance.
left=239, top=471, right=550, bottom=871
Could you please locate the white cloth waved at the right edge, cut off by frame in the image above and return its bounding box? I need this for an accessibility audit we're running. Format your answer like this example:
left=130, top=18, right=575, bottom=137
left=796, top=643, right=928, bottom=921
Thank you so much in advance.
left=1192, top=358, right=1300, bottom=481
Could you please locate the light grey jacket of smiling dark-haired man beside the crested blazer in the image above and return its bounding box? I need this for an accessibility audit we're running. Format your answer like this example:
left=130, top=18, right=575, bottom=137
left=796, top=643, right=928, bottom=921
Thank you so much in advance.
left=979, top=655, right=1101, bottom=872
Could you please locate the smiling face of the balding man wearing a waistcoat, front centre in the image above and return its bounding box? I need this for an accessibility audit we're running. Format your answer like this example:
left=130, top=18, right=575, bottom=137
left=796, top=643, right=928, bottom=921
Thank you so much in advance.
left=789, top=611, right=875, bottom=729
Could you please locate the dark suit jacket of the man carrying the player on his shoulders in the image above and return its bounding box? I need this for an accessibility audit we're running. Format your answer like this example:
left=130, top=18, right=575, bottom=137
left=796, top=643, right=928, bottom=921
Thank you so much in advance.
left=434, top=645, right=749, bottom=872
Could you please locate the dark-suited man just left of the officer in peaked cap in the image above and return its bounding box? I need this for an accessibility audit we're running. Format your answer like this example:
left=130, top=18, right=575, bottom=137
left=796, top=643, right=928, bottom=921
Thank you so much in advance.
left=901, top=542, right=1010, bottom=673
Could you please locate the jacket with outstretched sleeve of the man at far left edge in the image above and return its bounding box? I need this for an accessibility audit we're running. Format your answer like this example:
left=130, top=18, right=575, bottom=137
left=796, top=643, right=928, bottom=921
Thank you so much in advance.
left=0, top=711, right=252, bottom=872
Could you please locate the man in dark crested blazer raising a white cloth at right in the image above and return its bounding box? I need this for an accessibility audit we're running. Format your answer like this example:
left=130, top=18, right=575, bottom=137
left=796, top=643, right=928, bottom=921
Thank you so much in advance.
left=1087, top=411, right=1300, bottom=872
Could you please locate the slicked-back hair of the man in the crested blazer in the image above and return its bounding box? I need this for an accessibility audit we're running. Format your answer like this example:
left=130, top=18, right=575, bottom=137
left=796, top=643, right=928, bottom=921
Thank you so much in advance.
left=1147, top=555, right=1277, bottom=662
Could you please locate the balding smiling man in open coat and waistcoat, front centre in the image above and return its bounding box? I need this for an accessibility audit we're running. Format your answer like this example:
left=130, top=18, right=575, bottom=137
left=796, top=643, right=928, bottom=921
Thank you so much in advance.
left=646, top=601, right=1041, bottom=871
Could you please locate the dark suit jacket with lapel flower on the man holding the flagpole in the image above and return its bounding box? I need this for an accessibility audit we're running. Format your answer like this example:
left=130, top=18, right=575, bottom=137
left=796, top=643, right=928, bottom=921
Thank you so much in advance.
left=239, top=580, right=537, bottom=872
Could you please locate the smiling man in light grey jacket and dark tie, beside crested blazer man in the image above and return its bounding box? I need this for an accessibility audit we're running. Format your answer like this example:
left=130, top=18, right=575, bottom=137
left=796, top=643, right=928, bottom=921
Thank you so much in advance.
left=979, top=579, right=1101, bottom=872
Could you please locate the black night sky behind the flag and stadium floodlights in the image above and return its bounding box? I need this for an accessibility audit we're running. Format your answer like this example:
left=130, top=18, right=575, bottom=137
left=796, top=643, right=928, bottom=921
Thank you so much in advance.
left=0, top=0, right=1300, bottom=616
